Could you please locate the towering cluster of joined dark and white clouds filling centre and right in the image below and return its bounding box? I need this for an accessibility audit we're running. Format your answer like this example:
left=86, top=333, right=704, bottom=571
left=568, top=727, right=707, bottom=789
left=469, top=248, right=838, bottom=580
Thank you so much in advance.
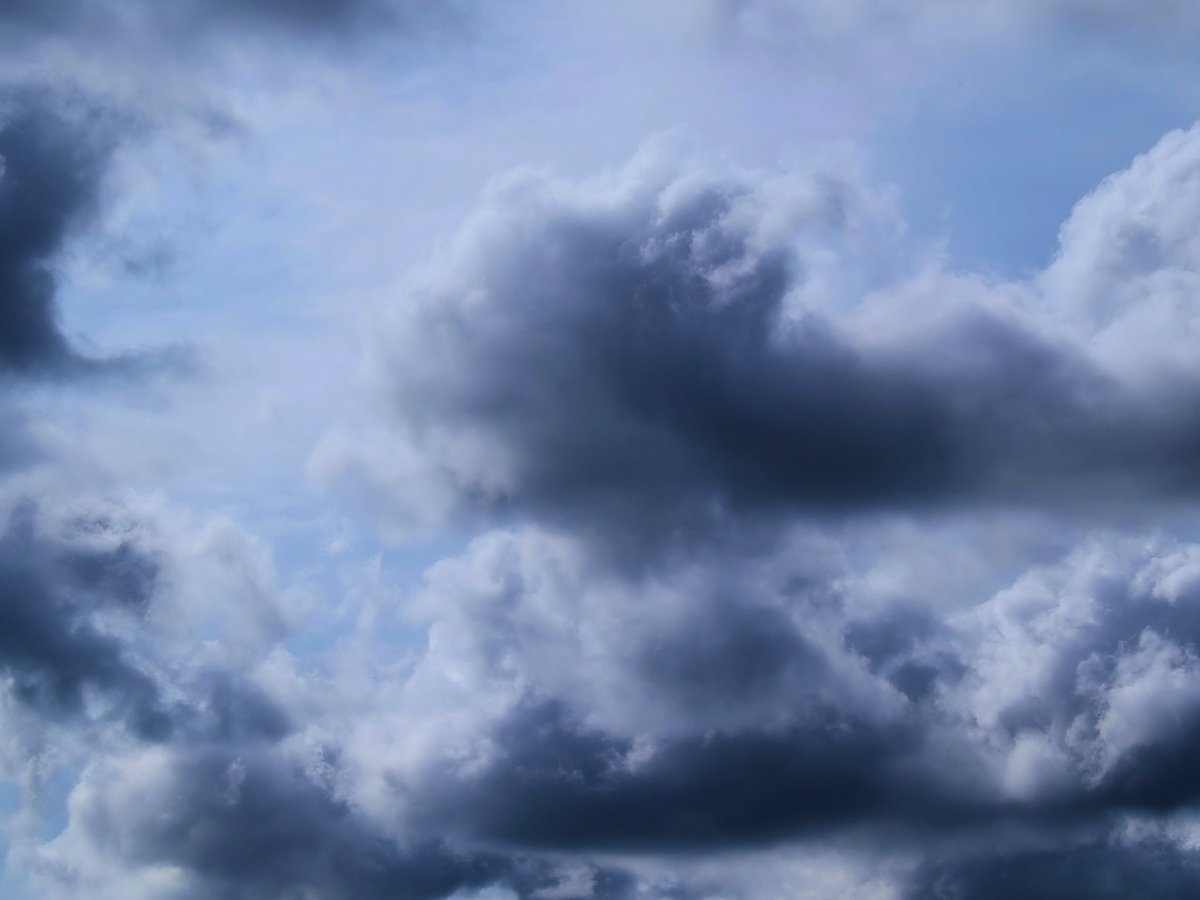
left=300, top=121, right=1200, bottom=896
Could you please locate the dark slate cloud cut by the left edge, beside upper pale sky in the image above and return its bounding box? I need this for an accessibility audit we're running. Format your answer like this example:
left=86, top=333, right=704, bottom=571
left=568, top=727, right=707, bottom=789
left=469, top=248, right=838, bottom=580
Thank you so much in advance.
left=0, top=90, right=116, bottom=372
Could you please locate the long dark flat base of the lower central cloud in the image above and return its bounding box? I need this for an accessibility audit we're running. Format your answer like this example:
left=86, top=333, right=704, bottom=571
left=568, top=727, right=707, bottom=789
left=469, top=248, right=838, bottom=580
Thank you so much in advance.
left=426, top=701, right=941, bottom=853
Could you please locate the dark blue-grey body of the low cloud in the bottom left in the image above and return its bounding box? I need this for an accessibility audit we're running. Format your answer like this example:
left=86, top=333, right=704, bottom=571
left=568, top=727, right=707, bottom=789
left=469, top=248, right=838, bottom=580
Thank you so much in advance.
left=84, top=748, right=511, bottom=900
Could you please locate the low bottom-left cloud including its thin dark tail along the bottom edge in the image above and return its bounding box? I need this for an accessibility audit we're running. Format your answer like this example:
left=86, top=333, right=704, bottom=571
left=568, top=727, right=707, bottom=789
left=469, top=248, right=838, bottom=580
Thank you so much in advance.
left=57, top=742, right=657, bottom=900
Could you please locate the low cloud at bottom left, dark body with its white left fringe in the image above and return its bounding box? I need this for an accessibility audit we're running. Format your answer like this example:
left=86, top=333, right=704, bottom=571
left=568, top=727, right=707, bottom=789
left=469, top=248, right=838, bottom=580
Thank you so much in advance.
left=41, top=744, right=511, bottom=899
